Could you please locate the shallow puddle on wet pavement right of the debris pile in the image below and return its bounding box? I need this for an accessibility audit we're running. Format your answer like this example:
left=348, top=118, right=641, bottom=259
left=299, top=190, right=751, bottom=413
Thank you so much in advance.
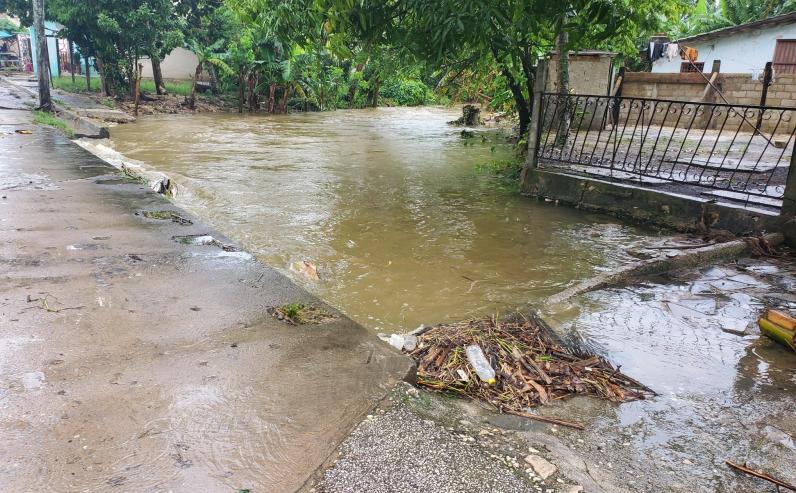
left=548, top=259, right=796, bottom=492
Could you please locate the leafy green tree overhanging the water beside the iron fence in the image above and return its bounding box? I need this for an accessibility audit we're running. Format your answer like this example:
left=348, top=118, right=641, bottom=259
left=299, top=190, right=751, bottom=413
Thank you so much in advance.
left=324, top=0, right=677, bottom=135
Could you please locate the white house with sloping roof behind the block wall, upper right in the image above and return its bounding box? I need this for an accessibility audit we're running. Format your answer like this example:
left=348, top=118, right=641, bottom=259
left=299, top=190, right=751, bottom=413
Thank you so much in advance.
left=652, top=12, right=796, bottom=76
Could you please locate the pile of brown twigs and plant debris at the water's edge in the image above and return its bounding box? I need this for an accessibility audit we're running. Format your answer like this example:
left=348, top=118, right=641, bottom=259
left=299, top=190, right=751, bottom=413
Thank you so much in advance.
left=405, top=315, right=653, bottom=415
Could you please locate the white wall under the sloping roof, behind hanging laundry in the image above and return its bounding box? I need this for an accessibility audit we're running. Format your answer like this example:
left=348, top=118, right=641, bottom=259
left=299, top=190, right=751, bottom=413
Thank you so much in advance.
left=652, top=23, right=796, bottom=73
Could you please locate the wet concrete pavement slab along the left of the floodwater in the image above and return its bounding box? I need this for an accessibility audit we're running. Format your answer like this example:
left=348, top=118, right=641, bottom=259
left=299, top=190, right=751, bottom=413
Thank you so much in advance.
left=0, top=91, right=409, bottom=492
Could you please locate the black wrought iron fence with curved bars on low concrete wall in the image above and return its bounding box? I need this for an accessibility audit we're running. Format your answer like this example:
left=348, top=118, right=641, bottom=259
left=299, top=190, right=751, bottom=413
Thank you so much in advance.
left=537, top=93, right=796, bottom=208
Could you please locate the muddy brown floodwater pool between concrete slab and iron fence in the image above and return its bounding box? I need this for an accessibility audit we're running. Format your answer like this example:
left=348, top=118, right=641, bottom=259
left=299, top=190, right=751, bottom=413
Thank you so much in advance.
left=112, top=108, right=640, bottom=332
